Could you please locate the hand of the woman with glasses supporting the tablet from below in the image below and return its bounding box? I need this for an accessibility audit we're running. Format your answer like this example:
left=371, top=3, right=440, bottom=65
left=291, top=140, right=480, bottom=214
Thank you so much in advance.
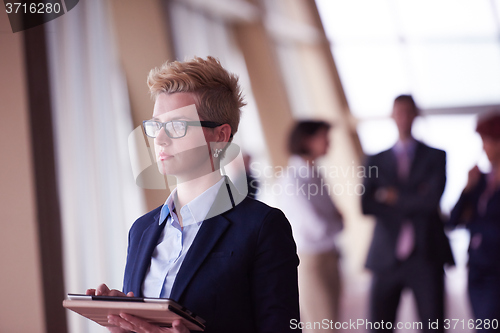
left=108, top=313, right=189, bottom=333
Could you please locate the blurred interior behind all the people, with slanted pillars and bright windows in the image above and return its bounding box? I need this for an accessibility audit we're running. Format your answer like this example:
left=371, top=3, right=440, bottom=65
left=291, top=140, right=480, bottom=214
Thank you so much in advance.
left=0, top=0, right=500, bottom=333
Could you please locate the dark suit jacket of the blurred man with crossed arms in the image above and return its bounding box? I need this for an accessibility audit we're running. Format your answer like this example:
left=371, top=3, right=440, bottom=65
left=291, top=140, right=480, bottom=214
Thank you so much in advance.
left=362, top=142, right=453, bottom=271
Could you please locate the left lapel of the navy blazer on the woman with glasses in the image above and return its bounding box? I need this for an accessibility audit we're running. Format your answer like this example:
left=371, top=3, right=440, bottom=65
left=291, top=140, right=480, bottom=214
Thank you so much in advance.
left=130, top=213, right=165, bottom=297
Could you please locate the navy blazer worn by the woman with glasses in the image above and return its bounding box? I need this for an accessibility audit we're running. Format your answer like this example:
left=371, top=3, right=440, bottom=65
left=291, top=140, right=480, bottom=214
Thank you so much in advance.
left=123, top=179, right=299, bottom=333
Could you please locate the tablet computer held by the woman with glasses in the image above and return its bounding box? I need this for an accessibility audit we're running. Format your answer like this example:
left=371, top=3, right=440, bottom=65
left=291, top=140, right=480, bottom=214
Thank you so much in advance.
left=63, top=294, right=205, bottom=331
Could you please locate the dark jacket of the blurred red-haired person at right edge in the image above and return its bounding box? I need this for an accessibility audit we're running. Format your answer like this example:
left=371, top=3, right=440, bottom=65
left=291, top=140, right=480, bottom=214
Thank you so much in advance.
left=450, top=174, right=500, bottom=274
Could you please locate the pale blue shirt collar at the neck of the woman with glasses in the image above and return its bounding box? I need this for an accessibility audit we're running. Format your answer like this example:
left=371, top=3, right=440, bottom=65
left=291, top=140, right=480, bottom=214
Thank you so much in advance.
left=159, top=177, right=225, bottom=226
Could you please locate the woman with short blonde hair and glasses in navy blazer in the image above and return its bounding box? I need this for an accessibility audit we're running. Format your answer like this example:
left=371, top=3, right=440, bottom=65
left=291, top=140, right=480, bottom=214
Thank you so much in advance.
left=87, top=57, right=299, bottom=333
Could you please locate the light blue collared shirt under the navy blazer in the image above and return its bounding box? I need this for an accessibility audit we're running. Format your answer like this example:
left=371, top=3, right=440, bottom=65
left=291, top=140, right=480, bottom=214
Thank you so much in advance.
left=142, top=177, right=224, bottom=298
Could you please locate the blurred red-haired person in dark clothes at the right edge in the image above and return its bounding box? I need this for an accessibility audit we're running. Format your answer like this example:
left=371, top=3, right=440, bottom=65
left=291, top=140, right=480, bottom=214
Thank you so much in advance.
left=450, top=113, right=500, bottom=330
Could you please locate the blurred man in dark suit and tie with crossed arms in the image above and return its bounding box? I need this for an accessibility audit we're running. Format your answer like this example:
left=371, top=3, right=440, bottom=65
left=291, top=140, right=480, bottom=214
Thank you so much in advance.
left=362, top=95, right=453, bottom=332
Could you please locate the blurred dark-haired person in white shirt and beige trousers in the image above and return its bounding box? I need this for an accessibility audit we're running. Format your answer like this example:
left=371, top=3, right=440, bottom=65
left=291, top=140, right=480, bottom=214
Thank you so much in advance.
left=280, top=121, right=343, bottom=333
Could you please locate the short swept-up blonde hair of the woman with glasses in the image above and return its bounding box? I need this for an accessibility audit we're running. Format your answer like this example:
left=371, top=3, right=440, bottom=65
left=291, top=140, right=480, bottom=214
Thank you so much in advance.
left=147, top=56, right=246, bottom=135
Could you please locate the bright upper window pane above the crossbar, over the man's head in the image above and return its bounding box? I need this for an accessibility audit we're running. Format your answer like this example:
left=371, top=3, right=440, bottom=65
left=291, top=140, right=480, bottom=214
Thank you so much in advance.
left=316, top=0, right=500, bottom=118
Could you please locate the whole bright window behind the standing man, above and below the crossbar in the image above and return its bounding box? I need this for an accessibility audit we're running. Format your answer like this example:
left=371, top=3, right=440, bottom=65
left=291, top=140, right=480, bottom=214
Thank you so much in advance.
left=316, top=0, right=500, bottom=212
